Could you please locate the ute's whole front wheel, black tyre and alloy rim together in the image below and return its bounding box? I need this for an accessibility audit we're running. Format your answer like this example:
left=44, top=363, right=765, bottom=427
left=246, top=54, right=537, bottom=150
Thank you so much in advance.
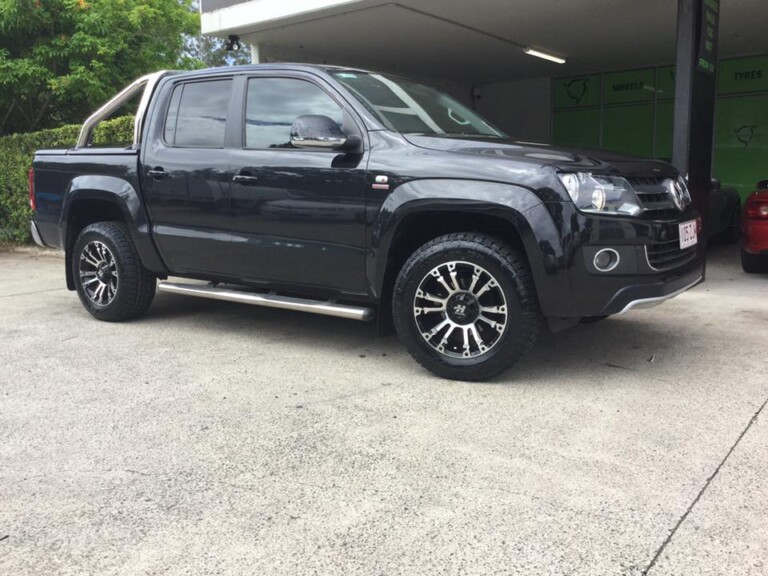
left=392, top=233, right=541, bottom=380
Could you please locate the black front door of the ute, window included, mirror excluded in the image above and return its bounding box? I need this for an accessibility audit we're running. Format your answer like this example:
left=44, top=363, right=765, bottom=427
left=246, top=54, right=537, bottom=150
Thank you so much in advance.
left=225, top=73, right=367, bottom=293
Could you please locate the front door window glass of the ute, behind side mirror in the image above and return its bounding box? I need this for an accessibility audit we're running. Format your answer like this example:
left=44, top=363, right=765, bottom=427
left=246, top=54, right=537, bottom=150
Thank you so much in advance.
left=245, top=78, right=344, bottom=148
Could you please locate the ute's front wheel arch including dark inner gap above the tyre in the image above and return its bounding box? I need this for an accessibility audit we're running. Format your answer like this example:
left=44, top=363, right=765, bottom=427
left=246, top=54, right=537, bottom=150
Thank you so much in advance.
left=366, top=180, right=568, bottom=331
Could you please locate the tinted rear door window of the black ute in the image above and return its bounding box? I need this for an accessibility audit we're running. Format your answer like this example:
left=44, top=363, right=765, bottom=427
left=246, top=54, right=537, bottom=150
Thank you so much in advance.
left=164, top=80, right=232, bottom=148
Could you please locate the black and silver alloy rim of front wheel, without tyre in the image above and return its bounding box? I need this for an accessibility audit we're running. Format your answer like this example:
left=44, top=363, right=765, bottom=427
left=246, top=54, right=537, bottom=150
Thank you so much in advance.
left=413, top=262, right=509, bottom=358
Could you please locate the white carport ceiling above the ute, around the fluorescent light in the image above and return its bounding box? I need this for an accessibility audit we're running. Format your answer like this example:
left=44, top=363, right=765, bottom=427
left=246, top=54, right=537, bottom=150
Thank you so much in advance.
left=227, top=0, right=768, bottom=84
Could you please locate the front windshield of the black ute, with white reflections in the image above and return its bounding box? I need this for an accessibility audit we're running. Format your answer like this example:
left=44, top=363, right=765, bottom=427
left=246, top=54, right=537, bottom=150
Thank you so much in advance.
left=332, top=71, right=505, bottom=138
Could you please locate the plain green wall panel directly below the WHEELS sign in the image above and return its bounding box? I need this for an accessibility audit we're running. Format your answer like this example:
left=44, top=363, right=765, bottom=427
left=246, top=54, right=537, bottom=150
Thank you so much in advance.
left=603, top=104, right=653, bottom=158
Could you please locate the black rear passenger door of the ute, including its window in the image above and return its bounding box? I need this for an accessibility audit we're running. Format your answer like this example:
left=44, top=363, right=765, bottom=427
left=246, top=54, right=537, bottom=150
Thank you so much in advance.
left=142, top=76, right=236, bottom=275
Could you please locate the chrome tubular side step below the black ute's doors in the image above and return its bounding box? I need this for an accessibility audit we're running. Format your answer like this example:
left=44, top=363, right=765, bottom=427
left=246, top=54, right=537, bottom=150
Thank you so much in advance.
left=157, top=282, right=374, bottom=321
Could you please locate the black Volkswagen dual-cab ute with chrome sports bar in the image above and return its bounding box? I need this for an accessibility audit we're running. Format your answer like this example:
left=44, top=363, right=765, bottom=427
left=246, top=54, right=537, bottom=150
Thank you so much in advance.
left=30, top=64, right=704, bottom=380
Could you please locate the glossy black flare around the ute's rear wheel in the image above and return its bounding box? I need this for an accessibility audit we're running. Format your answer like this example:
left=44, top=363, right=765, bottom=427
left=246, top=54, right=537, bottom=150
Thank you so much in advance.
left=59, top=175, right=168, bottom=284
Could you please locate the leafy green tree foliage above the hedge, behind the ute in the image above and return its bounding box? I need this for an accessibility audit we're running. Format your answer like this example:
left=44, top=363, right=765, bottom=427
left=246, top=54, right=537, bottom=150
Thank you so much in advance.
left=0, top=0, right=200, bottom=135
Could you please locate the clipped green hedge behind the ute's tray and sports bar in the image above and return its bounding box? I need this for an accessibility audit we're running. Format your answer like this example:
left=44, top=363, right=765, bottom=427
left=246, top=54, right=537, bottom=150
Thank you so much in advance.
left=0, top=116, right=133, bottom=243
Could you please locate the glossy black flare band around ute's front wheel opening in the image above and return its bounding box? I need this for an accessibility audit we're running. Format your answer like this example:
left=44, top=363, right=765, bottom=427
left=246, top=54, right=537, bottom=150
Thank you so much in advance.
left=366, top=179, right=569, bottom=316
